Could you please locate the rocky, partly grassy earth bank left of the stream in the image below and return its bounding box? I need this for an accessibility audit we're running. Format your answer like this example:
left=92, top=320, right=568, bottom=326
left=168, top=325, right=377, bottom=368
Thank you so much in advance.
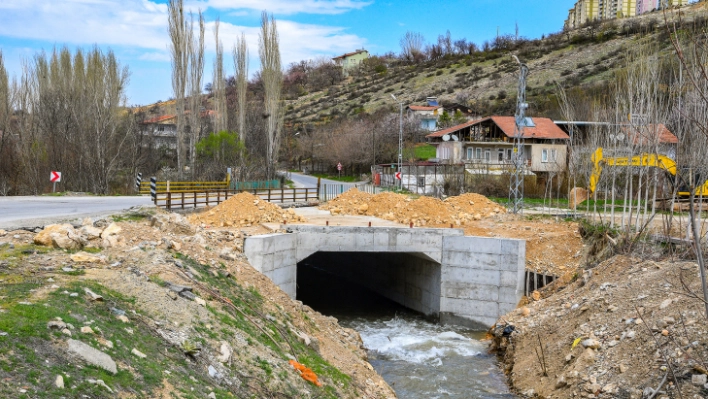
left=0, top=206, right=395, bottom=399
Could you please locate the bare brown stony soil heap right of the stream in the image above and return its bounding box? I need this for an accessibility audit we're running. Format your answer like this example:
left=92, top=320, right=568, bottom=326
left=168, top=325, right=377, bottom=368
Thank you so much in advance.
left=495, top=256, right=708, bottom=399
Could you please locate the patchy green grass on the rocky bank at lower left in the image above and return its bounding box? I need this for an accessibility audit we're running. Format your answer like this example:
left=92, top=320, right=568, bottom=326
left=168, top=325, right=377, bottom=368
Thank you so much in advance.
left=0, top=282, right=218, bottom=398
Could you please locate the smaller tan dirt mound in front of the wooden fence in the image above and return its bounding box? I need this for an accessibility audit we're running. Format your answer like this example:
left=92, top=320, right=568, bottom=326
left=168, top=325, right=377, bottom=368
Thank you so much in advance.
left=189, top=192, right=304, bottom=227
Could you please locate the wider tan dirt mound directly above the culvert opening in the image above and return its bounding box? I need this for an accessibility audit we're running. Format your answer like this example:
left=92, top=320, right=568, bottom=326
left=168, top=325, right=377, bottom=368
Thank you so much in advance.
left=320, top=188, right=506, bottom=226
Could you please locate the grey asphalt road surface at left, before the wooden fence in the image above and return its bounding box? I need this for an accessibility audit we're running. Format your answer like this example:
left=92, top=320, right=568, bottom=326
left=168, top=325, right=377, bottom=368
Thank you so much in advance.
left=0, top=196, right=152, bottom=230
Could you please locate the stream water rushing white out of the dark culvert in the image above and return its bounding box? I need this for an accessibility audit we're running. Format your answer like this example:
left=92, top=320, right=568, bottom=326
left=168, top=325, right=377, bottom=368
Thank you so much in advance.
left=298, top=267, right=514, bottom=399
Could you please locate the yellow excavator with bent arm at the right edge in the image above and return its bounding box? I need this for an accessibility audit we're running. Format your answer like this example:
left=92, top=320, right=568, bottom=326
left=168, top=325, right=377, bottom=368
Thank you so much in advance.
left=588, top=147, right=708, bottom=200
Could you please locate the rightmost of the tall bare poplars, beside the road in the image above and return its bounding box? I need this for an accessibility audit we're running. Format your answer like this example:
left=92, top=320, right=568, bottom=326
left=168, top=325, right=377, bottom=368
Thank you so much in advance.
left=258, top=11, right=283, bottom=179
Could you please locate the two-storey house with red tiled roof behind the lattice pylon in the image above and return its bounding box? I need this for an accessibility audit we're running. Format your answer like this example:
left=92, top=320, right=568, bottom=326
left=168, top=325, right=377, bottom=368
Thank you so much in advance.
left=426, top=116, right=570, bottom=177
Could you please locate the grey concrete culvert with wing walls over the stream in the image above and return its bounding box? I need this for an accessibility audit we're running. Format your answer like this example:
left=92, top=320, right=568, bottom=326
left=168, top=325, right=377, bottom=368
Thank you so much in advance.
left=244, top=226, right=526, bottom=328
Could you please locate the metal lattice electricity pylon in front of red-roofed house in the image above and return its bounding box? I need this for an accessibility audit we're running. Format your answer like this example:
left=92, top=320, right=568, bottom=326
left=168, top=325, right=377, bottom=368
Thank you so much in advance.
left=509, top=55, right=532, bottom=213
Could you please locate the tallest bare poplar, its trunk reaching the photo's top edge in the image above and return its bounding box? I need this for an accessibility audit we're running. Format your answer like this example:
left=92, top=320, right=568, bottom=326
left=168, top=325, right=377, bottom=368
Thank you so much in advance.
left=167, top=0, right=191, bottom=175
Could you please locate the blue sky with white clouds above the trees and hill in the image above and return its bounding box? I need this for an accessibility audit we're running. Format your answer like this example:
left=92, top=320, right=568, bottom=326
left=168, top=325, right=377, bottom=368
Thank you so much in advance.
left=0, top=0, right=575, bottom=105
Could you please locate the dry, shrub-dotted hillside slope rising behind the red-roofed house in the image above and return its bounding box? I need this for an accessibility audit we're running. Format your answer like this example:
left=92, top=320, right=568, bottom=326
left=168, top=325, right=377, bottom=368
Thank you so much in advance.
left=286, top=3, right=708, bottom=124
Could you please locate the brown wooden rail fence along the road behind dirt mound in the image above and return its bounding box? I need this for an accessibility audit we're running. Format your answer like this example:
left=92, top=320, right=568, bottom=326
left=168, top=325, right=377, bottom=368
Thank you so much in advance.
left=154, top=187, right=318, bottom=210
